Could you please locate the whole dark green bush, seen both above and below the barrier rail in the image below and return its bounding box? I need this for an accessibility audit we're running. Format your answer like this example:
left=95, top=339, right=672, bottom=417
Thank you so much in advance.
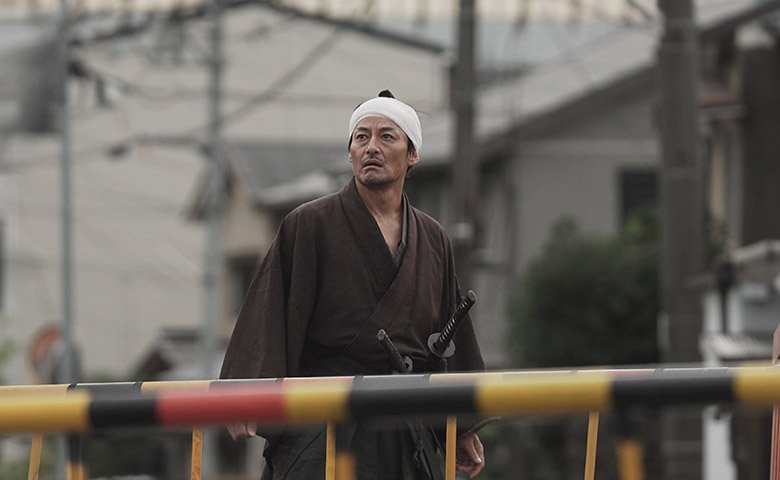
left=508, top=212, right=659, bottom=480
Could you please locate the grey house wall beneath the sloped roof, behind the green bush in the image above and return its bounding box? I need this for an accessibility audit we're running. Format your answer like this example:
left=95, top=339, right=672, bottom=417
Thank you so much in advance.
left=484, top=82, right=659, bottom=366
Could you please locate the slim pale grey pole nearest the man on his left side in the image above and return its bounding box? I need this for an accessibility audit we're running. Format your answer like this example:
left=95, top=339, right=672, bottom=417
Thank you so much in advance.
left=202, top=0, right=225, bottom=476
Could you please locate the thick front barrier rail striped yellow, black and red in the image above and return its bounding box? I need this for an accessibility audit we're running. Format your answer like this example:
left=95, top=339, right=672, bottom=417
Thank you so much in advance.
left=0, top=367, right=780, bottom=433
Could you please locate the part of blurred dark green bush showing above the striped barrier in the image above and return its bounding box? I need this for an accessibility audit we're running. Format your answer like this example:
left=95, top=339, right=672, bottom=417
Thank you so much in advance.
left=509, top=212, right=658, bottom=367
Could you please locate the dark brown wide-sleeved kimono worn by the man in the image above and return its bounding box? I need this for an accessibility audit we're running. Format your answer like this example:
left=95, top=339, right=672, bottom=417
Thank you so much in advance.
left=220, top=178, right=484, bottom=478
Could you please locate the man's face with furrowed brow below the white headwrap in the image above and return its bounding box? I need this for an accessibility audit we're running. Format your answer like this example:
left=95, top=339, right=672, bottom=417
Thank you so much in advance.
left=349, top=116, right=419, bottom=188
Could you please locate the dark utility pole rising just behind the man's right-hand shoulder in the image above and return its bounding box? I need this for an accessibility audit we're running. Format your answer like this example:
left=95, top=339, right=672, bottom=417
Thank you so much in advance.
left=450, top=0, right=479, bottom=289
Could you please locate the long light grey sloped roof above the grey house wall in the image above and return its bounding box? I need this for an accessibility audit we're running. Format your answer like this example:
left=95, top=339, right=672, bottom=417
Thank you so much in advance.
left=426, top=0, right=780, bottom=158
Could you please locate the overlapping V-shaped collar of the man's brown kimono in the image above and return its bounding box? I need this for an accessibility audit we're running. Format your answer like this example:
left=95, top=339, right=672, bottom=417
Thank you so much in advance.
left=342, top=179, right=417, bottom=359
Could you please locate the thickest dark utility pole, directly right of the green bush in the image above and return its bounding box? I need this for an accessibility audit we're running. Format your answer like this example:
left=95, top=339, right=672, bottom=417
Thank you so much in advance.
left=658, top=0, right=706, bottom=480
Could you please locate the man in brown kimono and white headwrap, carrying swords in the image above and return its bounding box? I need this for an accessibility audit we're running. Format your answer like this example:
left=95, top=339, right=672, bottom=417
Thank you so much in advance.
left=220, top=91, right=484, bottom=480
